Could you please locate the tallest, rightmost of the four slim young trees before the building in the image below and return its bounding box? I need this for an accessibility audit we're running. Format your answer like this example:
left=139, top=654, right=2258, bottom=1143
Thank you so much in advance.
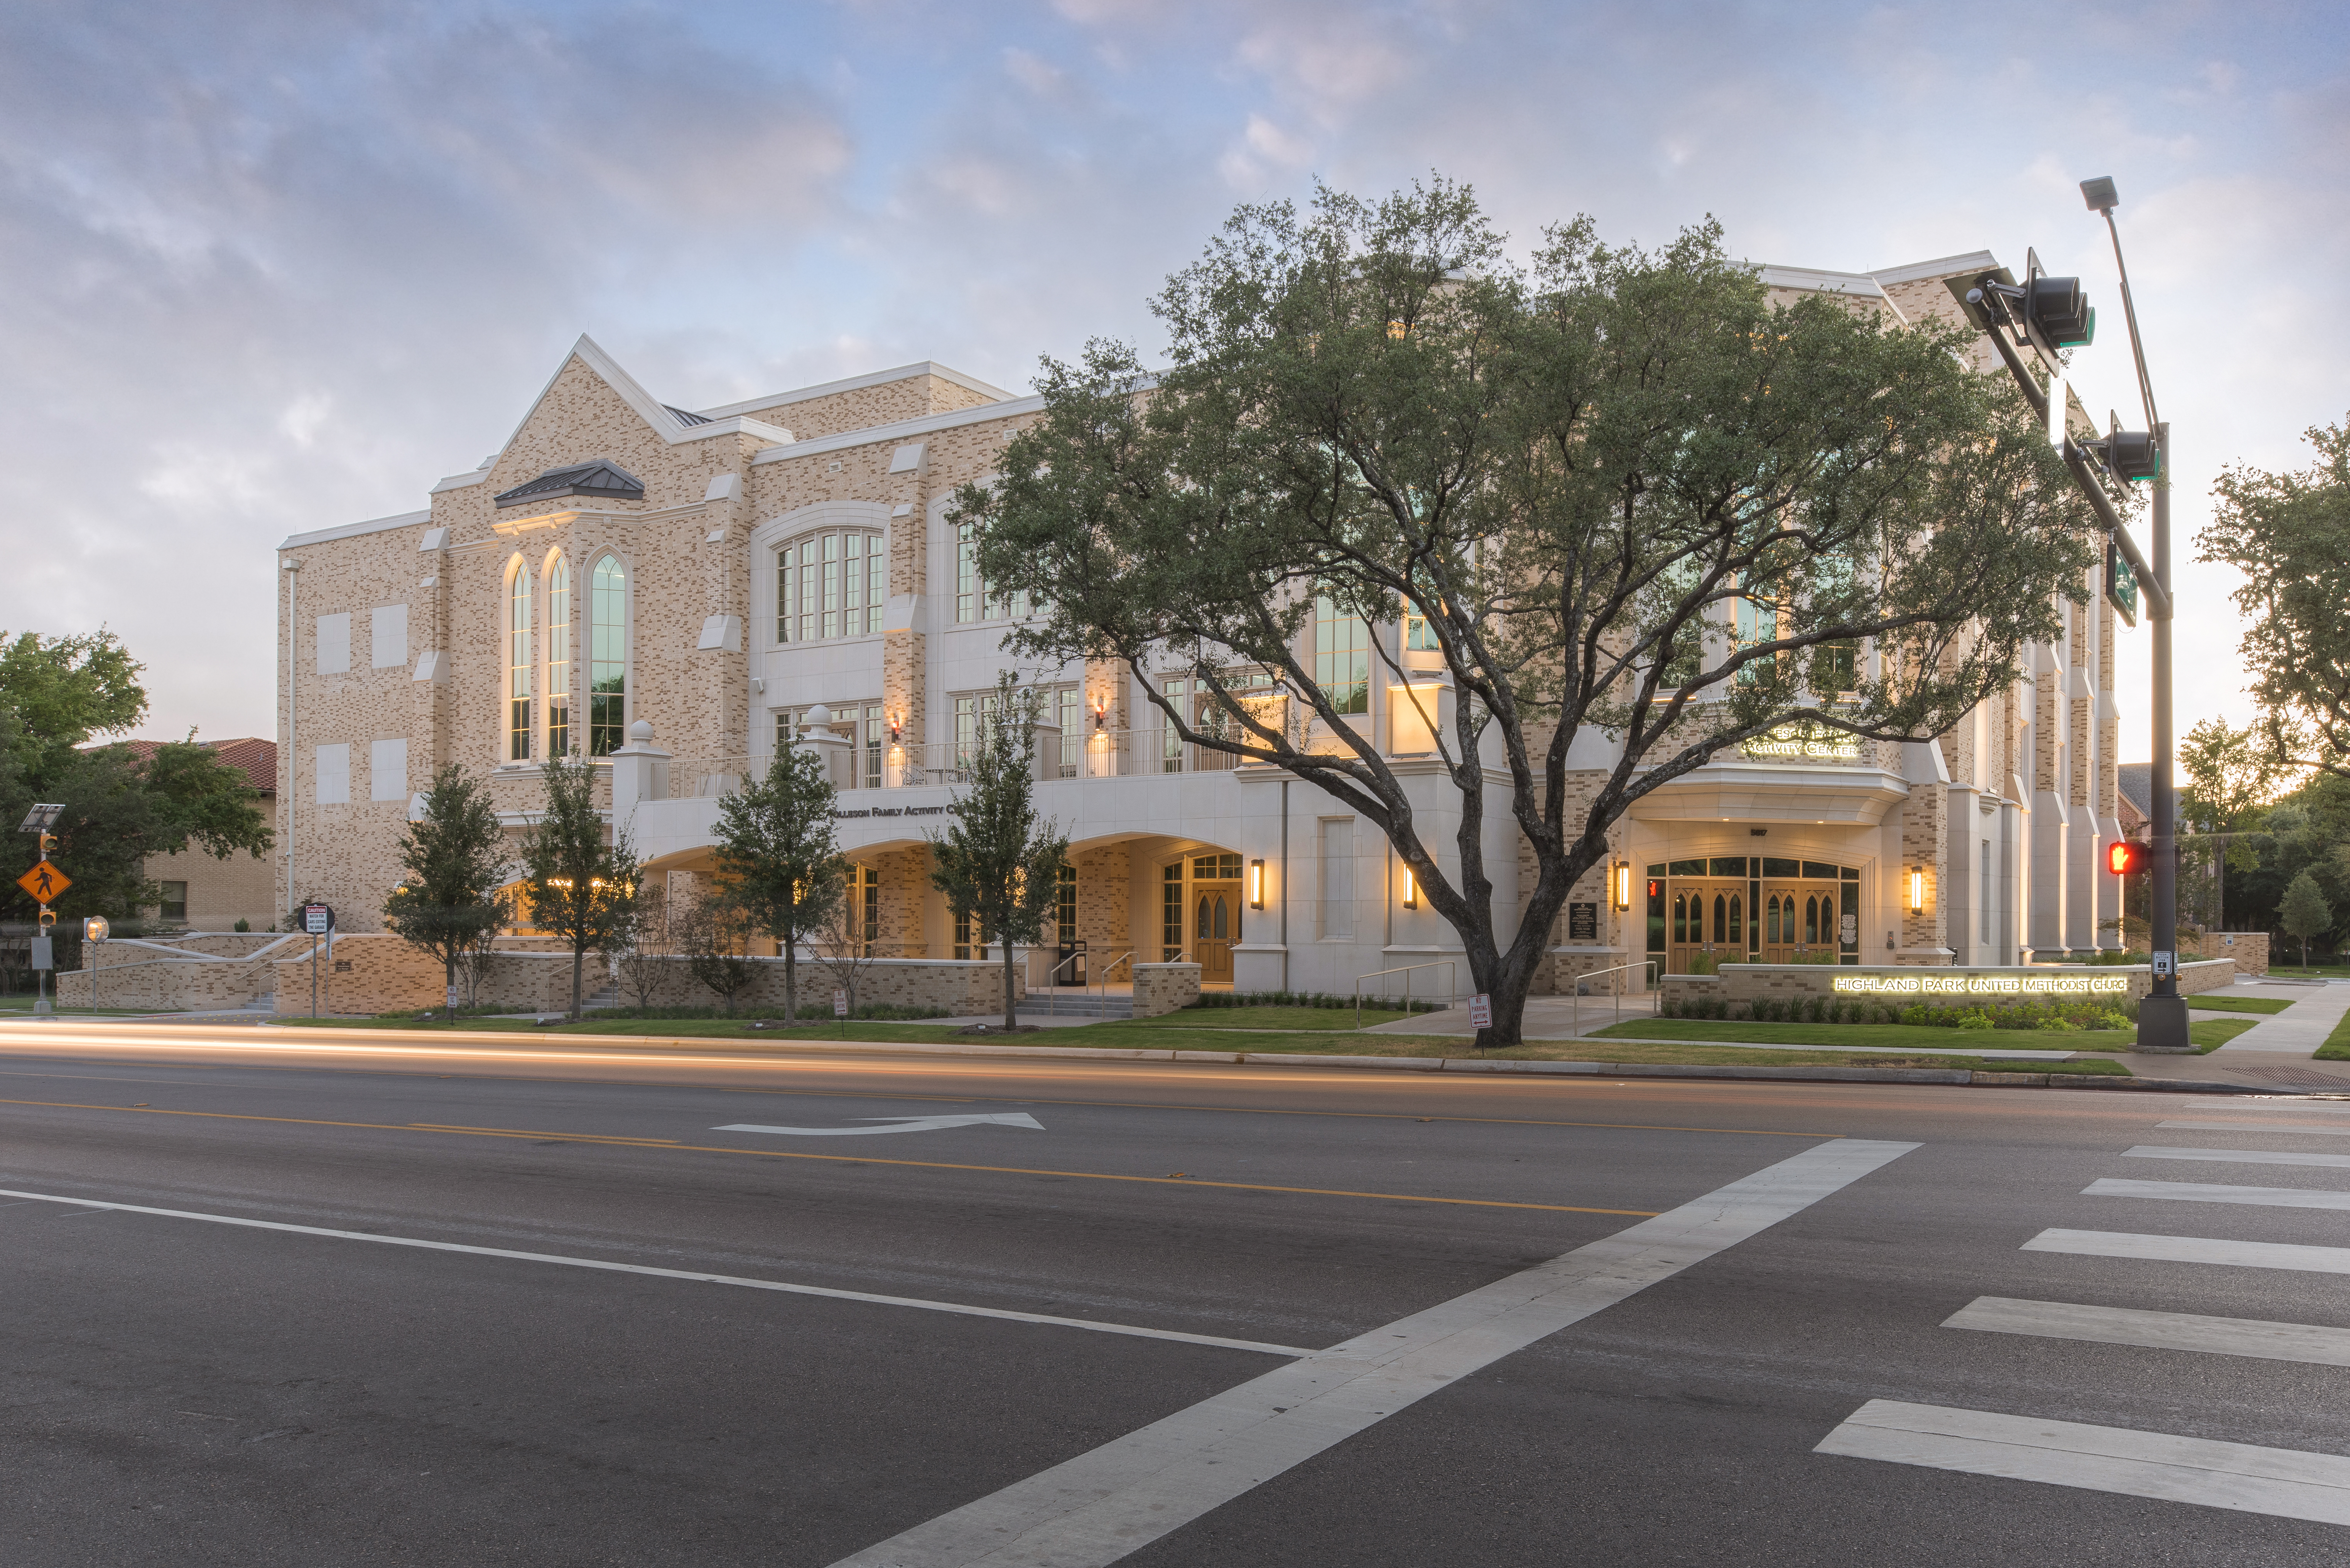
left=928, top=670, right=1069, bottom=1030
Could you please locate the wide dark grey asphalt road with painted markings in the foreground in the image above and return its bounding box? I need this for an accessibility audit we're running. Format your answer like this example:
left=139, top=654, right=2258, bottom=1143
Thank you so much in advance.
left=0, top=1025, right=2350, bottom=1568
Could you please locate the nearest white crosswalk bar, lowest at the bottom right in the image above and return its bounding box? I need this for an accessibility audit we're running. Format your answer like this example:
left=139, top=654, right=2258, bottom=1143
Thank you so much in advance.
left=1812, top=1399, right=2350, bottom=1523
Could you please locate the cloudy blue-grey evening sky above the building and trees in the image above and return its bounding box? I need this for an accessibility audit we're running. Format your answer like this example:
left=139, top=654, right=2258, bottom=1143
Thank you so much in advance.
left=0, top=0, right=2350, bottom=755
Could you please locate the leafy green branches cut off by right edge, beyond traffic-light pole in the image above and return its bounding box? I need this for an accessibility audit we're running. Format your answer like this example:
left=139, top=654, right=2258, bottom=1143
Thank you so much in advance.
left=2195, top=418, right=2350, bottom=778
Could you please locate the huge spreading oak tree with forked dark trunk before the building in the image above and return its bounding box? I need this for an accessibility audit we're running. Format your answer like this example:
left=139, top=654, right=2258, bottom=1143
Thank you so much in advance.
left=956, top=181, right=2092, bottom=1046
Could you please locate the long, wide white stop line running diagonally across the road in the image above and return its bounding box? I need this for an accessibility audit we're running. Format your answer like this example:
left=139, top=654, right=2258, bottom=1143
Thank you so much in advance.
left=834, top=1138, right=1918, bottom=1568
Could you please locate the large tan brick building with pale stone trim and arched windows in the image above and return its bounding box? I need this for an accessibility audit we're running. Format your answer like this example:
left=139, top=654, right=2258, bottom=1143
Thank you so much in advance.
left=268, top=254, right=2120, bottom=992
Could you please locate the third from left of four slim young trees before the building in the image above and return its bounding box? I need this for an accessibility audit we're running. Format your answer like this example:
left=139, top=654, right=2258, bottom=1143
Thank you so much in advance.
left=714, top=745, right=846, bottom=1018
